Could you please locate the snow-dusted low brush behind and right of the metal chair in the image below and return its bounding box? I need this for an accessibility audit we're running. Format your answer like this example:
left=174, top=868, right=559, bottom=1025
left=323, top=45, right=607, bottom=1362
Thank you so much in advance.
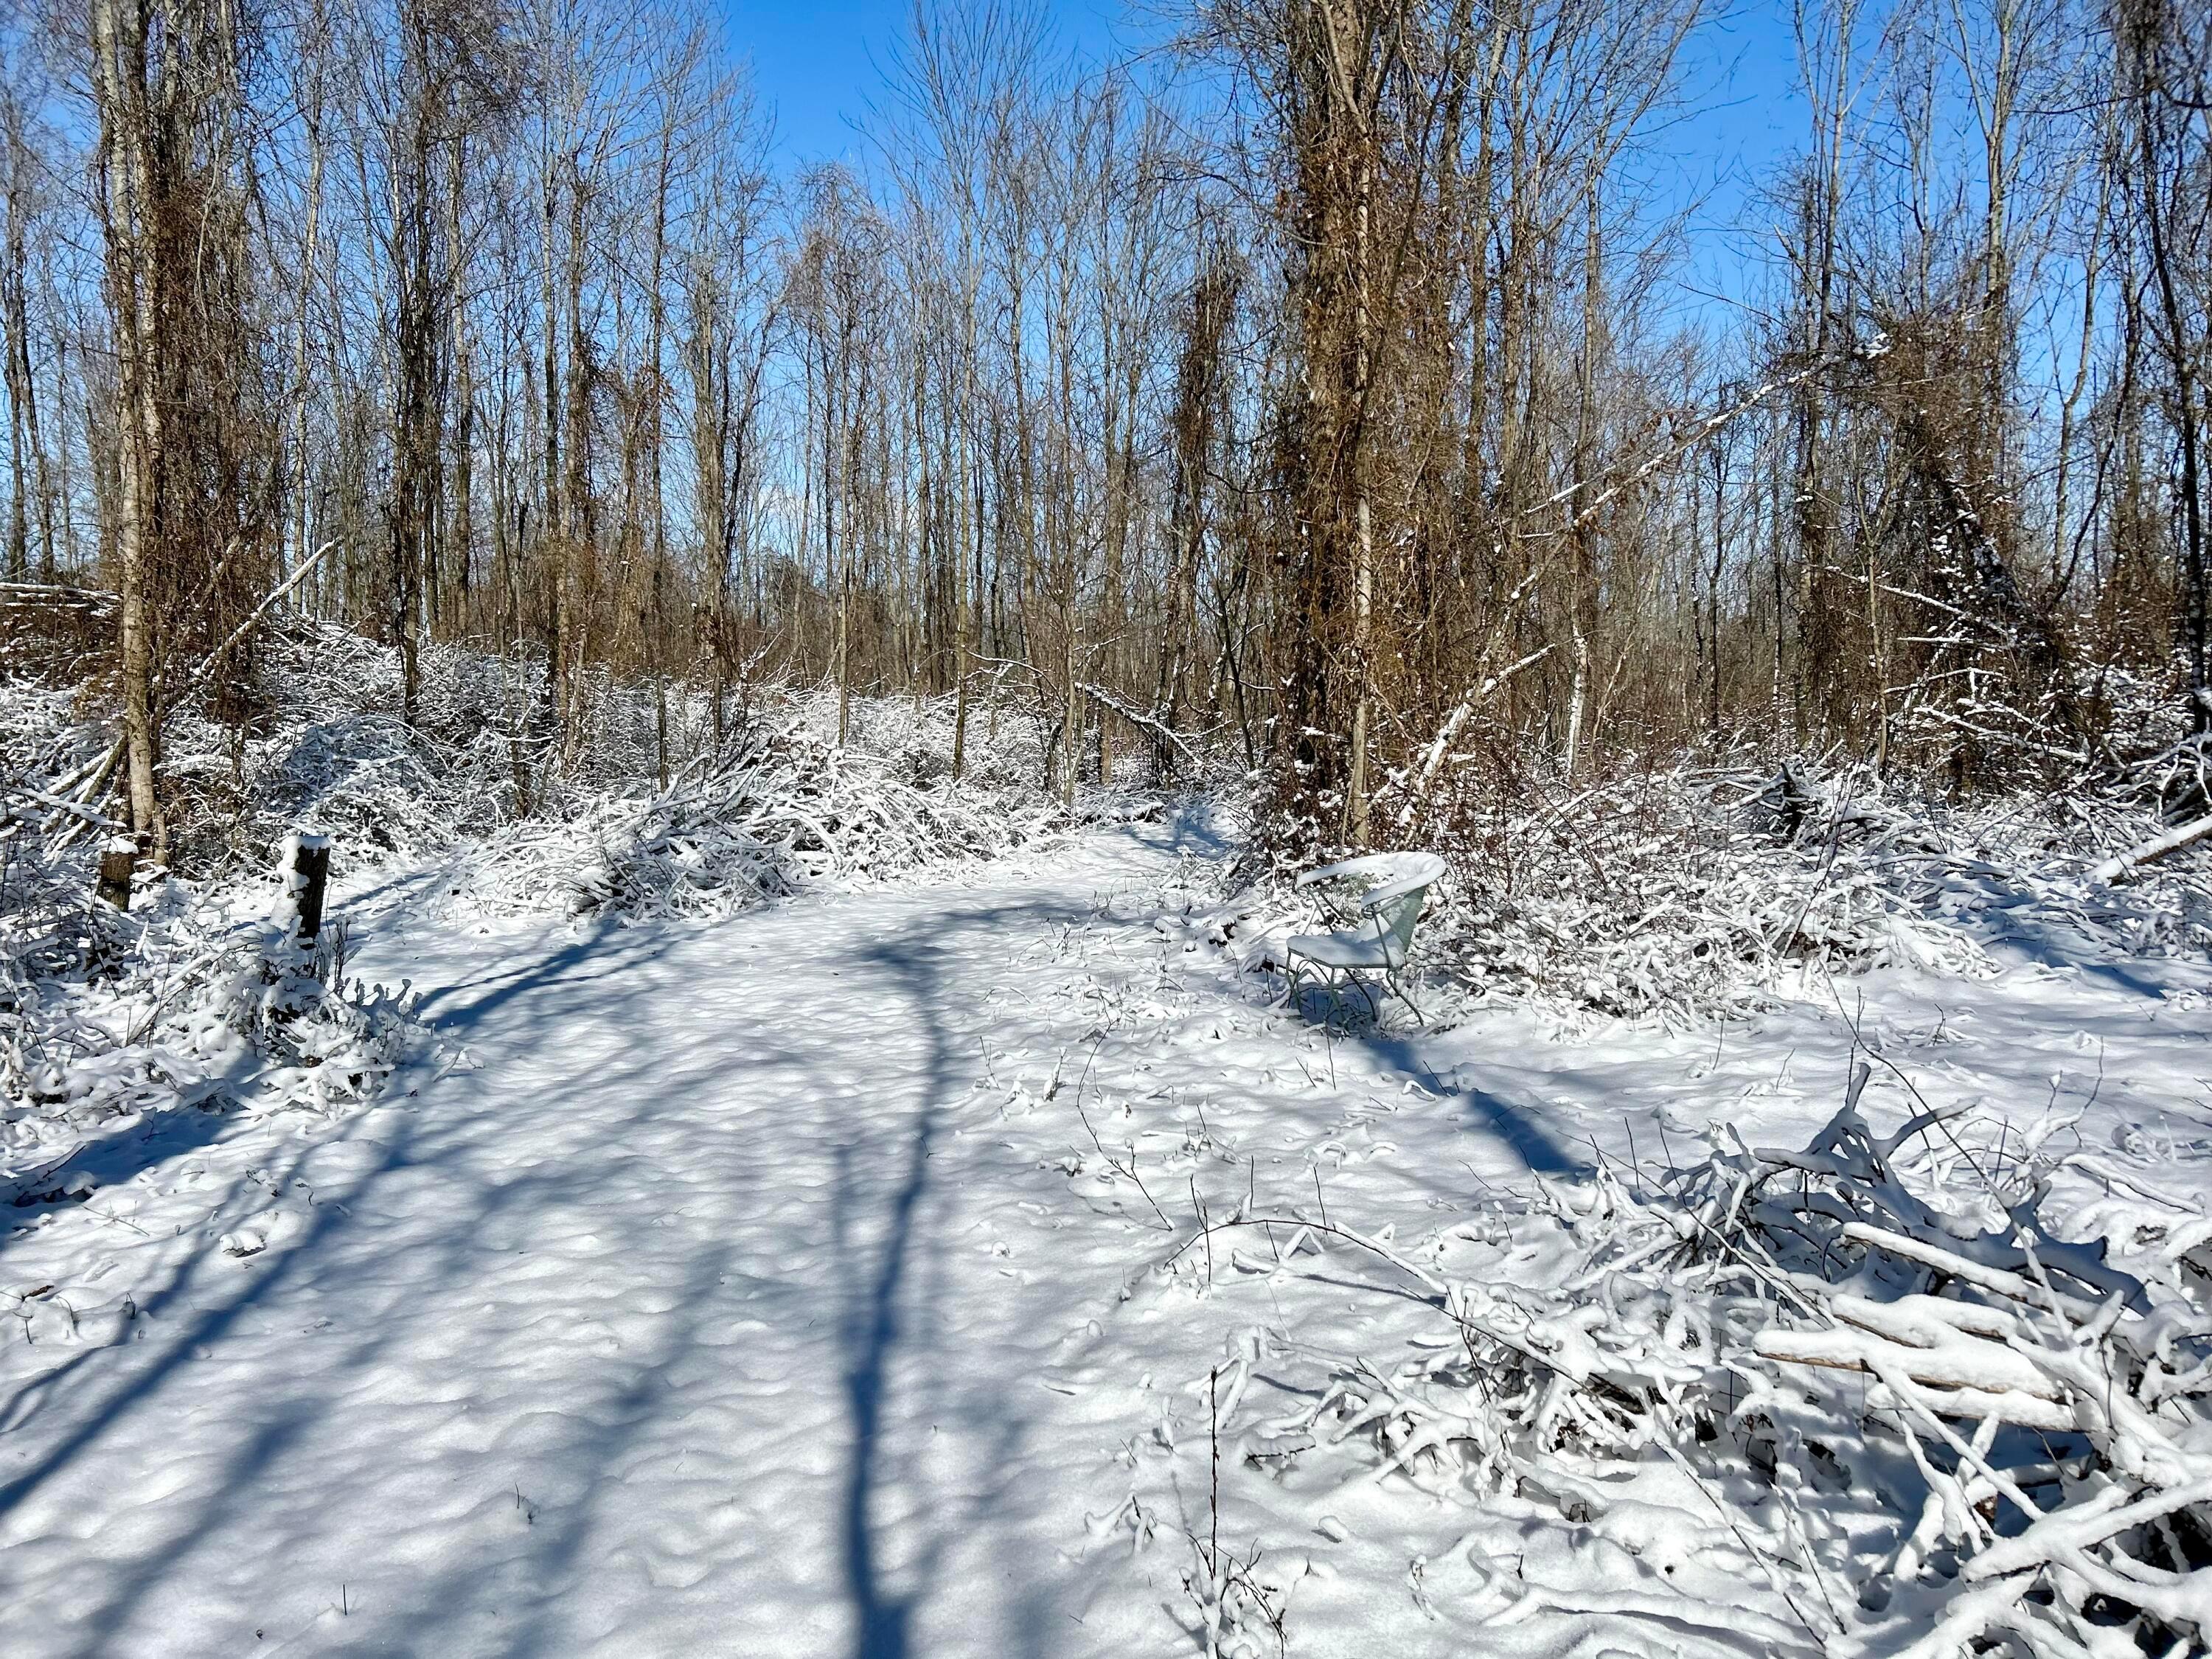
left=1239, top=763, right=2212, bottom=1026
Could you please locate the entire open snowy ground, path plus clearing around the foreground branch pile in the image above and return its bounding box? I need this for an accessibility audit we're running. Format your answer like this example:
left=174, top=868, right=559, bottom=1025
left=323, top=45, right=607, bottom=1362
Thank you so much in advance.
left=0, top=818, right=2212, bottom=1659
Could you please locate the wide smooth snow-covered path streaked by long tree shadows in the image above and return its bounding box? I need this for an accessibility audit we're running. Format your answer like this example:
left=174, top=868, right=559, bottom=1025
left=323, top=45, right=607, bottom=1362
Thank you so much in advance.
left=0, top=832, right=1248, bottom=1655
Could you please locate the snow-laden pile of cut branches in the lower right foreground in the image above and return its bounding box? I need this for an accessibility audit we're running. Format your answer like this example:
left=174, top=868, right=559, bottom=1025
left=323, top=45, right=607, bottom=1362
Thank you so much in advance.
left=1186, top=1068, right=2212, bottom=1659
